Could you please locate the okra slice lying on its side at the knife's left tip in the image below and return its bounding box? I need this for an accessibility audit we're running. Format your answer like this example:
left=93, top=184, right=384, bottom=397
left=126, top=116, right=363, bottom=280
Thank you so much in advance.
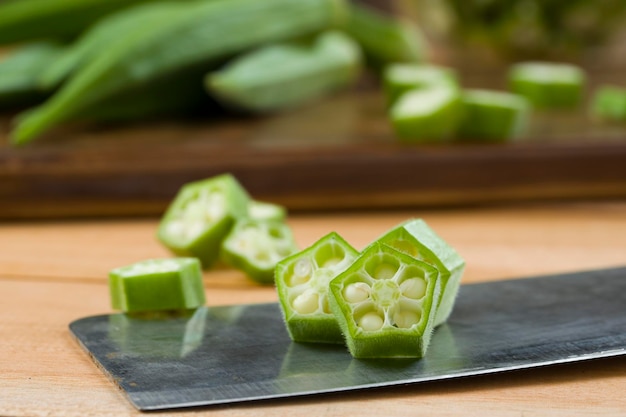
left=109, top=258, right=205, bottom=313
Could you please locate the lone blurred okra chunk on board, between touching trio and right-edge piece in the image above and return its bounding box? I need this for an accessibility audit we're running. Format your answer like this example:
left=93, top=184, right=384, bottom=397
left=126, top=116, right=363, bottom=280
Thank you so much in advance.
left=508, top=62, right=586, bottom=108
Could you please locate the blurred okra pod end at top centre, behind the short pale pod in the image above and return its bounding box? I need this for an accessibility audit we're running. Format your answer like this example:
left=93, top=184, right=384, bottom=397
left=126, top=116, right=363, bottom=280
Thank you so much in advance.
left=345, top=2, right=429, bottom=68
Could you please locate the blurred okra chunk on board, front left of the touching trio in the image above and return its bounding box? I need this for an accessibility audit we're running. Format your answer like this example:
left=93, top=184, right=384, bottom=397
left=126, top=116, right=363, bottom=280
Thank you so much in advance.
left=389, top=85, right=461, bottom=142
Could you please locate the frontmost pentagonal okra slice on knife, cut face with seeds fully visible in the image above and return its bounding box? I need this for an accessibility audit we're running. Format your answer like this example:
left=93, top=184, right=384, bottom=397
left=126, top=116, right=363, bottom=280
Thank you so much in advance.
left=330, top=242, right=440, bottom=358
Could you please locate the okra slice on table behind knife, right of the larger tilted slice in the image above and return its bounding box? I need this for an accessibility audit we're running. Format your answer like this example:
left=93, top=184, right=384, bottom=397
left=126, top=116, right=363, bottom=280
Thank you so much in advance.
left=221, top=219, right=297, bottom=284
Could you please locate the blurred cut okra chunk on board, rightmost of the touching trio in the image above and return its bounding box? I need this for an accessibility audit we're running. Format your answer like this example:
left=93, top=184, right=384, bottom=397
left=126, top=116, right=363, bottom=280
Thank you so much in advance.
left=458, top=89, right=530, bottom=141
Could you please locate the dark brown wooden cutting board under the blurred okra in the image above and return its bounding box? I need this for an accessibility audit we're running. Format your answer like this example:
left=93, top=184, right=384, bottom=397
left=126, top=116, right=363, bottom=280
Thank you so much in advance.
left=0, top=91, right=626, bottom=219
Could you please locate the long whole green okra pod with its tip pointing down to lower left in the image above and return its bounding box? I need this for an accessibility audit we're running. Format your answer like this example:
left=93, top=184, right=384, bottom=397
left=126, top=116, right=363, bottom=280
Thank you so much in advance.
left=12, top=0, right=345, bottom=144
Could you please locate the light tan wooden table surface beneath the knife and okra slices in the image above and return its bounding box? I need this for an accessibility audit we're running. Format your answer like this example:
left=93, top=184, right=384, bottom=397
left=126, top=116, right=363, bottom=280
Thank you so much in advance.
left=0, top=201, right=626, bottom=417
